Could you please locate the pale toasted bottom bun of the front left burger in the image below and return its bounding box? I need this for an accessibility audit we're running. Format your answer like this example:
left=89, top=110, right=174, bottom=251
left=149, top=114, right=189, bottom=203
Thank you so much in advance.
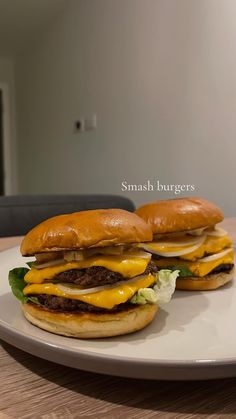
left=22, top=303, right=158, bottom=339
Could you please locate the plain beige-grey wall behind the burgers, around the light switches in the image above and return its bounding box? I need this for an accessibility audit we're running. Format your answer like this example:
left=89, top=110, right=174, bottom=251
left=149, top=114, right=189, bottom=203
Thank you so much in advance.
left=17, top=0, right=236, bottom=215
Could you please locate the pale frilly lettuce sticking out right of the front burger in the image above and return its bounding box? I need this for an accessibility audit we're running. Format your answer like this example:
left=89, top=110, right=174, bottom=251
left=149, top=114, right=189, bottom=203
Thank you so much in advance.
left=130, top=269, right=179, bottom=305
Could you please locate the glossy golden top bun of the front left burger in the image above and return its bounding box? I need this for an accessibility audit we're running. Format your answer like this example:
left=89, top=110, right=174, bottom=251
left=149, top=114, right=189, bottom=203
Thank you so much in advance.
left=21, top=209, right=152, bottom=256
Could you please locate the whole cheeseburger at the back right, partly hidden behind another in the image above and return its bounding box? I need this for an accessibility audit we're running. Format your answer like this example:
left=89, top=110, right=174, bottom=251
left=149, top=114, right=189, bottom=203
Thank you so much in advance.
left=136, top=198, right=234, bottom=290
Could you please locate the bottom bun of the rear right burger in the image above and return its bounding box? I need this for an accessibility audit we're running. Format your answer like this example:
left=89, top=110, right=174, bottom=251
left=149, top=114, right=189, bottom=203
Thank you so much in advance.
left=176, top=268, right=234, bottom=291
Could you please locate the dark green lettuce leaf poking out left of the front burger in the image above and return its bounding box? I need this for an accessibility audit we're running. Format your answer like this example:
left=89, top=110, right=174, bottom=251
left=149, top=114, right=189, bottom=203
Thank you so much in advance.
left=8, top=268, right=39, bottom=304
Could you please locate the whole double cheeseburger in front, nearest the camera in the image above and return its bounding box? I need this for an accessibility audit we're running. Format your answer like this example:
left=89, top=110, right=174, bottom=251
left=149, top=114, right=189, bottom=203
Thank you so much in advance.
left=9, top=209, right=178, bottom=338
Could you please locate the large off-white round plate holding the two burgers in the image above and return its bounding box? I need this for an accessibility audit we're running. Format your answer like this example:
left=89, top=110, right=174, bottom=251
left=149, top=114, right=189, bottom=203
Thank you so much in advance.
left=0, top=248, right=236, bottom=380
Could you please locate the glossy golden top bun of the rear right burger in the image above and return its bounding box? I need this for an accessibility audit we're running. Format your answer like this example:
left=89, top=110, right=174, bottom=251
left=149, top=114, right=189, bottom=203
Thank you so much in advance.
left=135, top=198, right=224, bottom=234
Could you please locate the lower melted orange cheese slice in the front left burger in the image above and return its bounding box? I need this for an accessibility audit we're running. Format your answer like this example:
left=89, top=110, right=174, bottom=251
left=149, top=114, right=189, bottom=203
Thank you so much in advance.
left=23, top=274, right=156, bottom=309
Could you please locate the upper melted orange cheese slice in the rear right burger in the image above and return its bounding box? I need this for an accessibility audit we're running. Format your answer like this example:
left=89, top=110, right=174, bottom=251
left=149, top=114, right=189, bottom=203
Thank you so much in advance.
left=180, top=235, right=233, bottom=261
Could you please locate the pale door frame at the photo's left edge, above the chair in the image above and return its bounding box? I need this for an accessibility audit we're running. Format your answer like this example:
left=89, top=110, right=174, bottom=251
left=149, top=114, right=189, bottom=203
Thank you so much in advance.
left=0, top=57, right=18, bottom=194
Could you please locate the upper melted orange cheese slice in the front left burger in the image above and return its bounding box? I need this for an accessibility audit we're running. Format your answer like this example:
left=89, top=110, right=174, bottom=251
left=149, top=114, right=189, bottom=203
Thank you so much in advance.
left=24, top=255, right=151, bottom=284
